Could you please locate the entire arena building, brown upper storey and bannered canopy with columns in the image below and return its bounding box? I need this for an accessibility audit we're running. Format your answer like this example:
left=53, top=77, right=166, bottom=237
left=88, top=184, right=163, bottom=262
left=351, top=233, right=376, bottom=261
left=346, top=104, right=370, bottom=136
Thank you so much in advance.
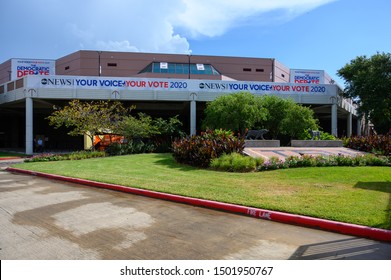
left=0, top=51, right=361, bottom=154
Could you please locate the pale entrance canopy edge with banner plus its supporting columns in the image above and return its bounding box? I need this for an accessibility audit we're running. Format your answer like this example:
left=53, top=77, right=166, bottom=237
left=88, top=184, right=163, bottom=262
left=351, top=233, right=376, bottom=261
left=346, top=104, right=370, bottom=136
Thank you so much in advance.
left=0, top=75, right=356, bottom=154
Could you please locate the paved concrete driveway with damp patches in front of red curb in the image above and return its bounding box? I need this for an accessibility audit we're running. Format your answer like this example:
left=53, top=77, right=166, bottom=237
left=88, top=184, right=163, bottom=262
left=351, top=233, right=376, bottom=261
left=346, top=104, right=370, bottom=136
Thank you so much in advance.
left=0, top=167, right=391, bottom=260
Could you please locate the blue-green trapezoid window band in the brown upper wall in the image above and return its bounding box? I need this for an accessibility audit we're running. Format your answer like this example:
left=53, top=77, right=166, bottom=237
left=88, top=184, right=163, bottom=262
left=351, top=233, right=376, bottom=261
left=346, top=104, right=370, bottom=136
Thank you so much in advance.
left=139, top=62, right=220, bottom=75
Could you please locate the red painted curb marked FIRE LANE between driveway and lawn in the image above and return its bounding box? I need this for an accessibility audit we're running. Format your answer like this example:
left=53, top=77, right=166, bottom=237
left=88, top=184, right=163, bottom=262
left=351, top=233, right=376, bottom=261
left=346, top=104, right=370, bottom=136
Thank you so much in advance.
left=6, top=167, right=391, bottom=242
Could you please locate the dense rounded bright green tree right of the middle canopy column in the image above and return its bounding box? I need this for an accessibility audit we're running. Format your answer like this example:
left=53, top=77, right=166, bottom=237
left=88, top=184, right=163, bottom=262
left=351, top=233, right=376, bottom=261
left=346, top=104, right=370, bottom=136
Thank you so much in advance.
left=203, top=92, right=318, bottom=139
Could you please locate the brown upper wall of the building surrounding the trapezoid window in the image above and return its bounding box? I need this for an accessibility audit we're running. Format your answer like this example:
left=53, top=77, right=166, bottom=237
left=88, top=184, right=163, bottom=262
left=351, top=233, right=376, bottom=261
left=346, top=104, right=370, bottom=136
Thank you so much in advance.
left=56, top=51, right=289, bottom=82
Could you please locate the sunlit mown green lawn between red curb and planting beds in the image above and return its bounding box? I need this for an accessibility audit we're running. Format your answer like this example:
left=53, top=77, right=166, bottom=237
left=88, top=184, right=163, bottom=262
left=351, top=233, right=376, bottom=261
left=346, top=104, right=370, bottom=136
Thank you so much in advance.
left=16, top=154, right=391, bottom=229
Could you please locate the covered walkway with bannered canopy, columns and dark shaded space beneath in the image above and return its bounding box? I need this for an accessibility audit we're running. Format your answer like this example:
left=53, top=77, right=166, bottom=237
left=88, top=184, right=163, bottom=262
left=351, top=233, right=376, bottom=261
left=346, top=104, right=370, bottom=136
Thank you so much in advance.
left=0, top=75, right=360, bottom=155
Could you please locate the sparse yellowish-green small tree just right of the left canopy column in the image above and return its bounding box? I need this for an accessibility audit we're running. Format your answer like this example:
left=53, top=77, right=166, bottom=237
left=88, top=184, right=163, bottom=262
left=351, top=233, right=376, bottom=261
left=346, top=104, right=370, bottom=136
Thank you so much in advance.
left=47, top=100, right=134, bottom=150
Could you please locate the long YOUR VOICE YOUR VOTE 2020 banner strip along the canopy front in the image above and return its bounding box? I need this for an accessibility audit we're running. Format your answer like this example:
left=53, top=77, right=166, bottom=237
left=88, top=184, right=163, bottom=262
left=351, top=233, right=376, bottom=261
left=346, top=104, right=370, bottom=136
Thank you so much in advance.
left=26, top=76, right=336, bottom=95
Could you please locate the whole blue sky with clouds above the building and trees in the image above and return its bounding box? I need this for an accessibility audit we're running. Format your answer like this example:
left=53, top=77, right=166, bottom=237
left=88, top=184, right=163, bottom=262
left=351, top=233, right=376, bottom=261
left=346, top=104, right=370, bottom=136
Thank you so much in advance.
left=0, top=0, right=391, bottom=85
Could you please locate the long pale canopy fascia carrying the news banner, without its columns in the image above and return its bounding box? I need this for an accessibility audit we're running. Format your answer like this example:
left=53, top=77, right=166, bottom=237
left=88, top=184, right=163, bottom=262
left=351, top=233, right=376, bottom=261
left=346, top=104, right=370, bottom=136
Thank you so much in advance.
left=0, top=76, right=344, bottom=104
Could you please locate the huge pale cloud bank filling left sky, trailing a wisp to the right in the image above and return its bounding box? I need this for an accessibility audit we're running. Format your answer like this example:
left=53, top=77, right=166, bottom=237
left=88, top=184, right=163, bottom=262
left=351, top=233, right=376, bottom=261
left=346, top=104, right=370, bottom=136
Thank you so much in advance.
left=0, top=0, right=337, bottom=61
